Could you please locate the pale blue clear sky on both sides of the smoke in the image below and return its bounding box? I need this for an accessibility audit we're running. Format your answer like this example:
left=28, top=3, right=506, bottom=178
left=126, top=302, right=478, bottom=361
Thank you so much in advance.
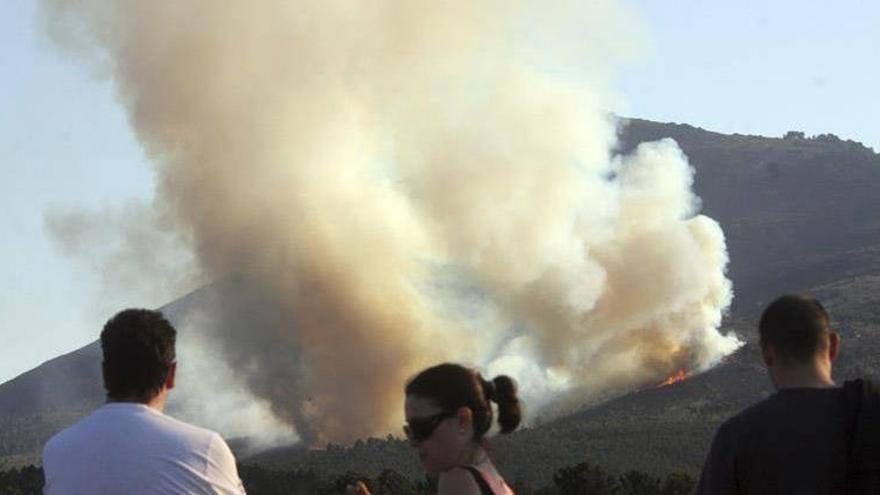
left=0, top=0, right=880, bottom=383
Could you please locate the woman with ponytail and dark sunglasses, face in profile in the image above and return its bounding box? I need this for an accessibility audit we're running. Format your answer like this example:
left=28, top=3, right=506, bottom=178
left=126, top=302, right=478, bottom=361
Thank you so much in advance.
left=349, top=363, right=521, bottom=495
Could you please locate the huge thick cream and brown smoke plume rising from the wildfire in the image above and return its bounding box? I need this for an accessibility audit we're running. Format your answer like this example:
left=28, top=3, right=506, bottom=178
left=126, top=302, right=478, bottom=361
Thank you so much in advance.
left=45, top=0, right=738, bottom=442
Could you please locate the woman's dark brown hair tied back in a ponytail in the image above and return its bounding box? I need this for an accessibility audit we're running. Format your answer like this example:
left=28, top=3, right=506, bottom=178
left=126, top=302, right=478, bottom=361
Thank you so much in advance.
left=406, top=363, right=522, bottom=442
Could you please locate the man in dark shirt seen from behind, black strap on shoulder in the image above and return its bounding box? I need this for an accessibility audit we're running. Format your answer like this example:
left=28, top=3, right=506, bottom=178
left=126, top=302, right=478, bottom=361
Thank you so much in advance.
left=696, top=294, right=880, bottom=495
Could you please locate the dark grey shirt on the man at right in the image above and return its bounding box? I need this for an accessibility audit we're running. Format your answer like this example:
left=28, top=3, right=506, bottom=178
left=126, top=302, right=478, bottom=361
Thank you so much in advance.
left=696, top=388, right=847, bottom=495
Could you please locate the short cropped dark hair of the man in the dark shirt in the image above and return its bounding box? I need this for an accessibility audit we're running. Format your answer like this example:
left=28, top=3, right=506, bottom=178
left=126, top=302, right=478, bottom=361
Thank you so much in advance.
left=758, top=294, right=831, bottom=363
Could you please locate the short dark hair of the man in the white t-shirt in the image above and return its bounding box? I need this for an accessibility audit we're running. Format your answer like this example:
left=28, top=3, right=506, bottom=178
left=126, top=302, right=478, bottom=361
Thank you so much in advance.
left=101, top=309, right=177, bottom=401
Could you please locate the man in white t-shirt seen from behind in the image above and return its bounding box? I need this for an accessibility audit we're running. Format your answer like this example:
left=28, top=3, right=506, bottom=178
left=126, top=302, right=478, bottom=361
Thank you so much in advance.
left=43, top=309, right=244, bottom=494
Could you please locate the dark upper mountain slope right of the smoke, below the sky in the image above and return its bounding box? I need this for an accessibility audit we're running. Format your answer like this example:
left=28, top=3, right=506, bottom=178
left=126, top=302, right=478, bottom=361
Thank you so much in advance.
left=621, top=119, right=880, bottom=312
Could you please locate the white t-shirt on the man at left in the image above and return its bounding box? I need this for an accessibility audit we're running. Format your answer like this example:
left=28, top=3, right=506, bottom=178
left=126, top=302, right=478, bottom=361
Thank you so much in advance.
left=43, top=402, right=244, bottom=495
